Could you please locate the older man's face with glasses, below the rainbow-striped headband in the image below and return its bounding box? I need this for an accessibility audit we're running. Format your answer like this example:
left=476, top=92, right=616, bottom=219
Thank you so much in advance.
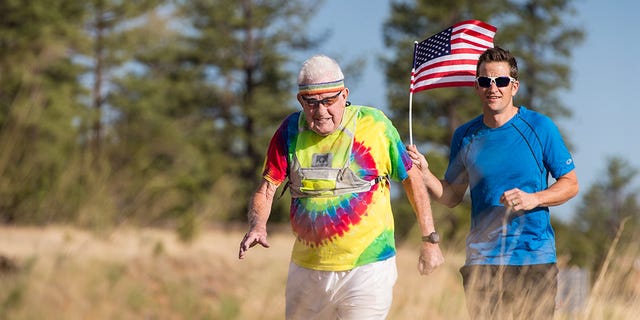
left=298, top=88, right=349, bottom=136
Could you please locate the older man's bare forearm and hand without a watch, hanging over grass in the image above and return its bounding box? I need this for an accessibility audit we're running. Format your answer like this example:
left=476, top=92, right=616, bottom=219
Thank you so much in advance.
left=238, top=179, right=278, bottom=259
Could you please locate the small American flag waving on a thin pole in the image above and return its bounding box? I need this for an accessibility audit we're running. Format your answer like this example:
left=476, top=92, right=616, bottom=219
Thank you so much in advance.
left=410, top=20, right=497, bottom=93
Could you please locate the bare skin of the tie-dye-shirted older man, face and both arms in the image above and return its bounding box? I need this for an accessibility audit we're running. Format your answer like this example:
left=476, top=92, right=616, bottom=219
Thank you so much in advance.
left=238, top=88, right=444, bottom=275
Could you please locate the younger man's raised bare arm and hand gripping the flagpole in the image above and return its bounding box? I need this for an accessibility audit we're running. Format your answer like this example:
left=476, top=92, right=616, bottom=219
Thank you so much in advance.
left=407, top=145, right=468, bottom=208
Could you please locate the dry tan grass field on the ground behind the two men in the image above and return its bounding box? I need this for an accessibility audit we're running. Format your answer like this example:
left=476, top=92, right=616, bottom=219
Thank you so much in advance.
left=0, top=226, right=640, bottom=319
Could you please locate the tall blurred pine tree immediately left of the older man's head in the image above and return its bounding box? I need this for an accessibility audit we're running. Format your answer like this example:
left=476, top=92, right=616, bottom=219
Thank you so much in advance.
left=171, top=0, right=316, bottom=220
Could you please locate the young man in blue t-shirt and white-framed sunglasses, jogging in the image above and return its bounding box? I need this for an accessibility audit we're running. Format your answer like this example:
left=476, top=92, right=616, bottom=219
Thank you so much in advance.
left=409, top=48, right=578, bottom=319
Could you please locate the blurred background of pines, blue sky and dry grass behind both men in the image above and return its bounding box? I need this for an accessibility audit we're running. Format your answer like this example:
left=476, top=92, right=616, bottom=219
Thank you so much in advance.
left=0, top=0, right=640, bottom=319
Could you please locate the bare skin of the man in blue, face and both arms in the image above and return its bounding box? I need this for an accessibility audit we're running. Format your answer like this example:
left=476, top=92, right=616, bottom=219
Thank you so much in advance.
left=407, top=62, right=579, bottom=211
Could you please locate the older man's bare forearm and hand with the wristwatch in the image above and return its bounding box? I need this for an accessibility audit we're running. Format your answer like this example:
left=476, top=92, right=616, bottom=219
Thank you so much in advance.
left=402, top=166, right=444, bottom=275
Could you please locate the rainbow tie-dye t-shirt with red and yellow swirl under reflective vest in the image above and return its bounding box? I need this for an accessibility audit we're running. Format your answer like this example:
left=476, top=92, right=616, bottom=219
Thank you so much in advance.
left=263, top=106, right=412, bottom=271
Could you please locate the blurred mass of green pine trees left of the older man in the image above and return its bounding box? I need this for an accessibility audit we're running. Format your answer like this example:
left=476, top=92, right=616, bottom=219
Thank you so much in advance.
left=0, top=0, right=318, bottom=230
